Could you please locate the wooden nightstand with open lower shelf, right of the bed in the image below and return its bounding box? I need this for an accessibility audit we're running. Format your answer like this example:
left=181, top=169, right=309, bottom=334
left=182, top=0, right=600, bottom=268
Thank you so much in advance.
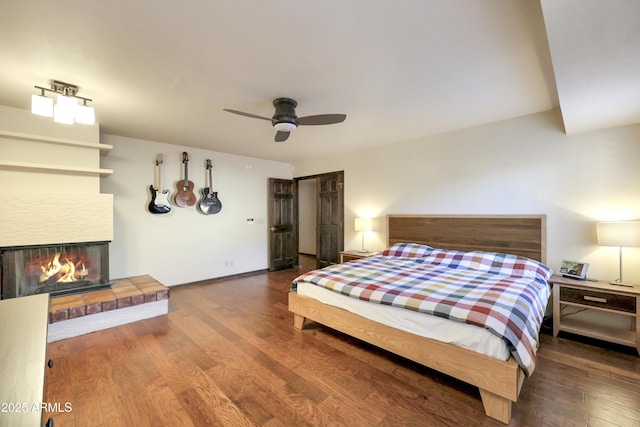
left=549, top=275, right=640, bottom=354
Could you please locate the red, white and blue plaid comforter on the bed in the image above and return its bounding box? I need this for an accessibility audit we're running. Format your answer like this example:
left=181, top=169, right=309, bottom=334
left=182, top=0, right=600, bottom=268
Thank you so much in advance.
left=292, top=244, right=552, bottom=376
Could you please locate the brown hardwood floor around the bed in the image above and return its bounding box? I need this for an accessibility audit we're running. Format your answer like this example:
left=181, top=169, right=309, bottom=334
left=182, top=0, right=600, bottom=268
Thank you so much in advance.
left=46, top=263, right=640, bottom=427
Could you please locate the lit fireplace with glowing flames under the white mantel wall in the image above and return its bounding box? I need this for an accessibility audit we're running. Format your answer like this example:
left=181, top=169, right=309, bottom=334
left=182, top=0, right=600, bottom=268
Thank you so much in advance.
left=0, top=242, right=111, bottom=299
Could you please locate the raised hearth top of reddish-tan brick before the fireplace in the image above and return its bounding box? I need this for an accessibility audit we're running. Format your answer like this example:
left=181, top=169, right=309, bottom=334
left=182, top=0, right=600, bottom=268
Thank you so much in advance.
left=49, top=275, right=169, bottom=323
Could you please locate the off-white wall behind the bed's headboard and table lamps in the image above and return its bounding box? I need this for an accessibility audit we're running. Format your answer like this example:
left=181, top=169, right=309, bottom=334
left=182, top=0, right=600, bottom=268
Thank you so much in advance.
left=294, top=110, right=640, bottom=283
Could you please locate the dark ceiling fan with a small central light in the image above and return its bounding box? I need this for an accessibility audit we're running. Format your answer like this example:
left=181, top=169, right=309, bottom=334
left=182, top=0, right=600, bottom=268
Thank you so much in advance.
left=224, top=98, right=347, bottom=142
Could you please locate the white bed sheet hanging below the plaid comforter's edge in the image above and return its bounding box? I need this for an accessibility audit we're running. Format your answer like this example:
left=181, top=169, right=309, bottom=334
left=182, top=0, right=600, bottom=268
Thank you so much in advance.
left=297, top=282, right=510, bottom=360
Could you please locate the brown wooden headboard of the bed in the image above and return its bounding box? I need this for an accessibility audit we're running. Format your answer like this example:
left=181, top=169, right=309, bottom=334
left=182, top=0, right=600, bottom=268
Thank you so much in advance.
left=387, top=215, right=547, bottom=263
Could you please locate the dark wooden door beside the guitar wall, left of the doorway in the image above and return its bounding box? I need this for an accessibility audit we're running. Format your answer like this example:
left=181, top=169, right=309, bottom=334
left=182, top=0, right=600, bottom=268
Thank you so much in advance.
left=268, top=178, right=298, bottom=271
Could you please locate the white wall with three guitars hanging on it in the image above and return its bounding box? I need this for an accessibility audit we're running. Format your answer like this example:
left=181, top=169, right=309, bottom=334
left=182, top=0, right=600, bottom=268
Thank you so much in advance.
left=101, top=135, right=292, bottom=286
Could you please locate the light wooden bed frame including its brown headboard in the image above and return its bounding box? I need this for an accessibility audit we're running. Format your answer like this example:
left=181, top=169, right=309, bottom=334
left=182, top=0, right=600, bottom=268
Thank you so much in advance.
left=289, top=215, right=546, bottom=424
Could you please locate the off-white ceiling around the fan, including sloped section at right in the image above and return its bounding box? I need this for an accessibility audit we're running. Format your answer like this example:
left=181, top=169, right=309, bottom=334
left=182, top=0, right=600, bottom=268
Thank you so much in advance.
left=0, top=0, right=640, bottom=162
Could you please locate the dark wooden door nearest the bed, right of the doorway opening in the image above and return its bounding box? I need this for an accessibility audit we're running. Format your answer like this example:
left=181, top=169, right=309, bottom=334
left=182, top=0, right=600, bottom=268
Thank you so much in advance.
left=316, top=172, right=344, bottom=268
